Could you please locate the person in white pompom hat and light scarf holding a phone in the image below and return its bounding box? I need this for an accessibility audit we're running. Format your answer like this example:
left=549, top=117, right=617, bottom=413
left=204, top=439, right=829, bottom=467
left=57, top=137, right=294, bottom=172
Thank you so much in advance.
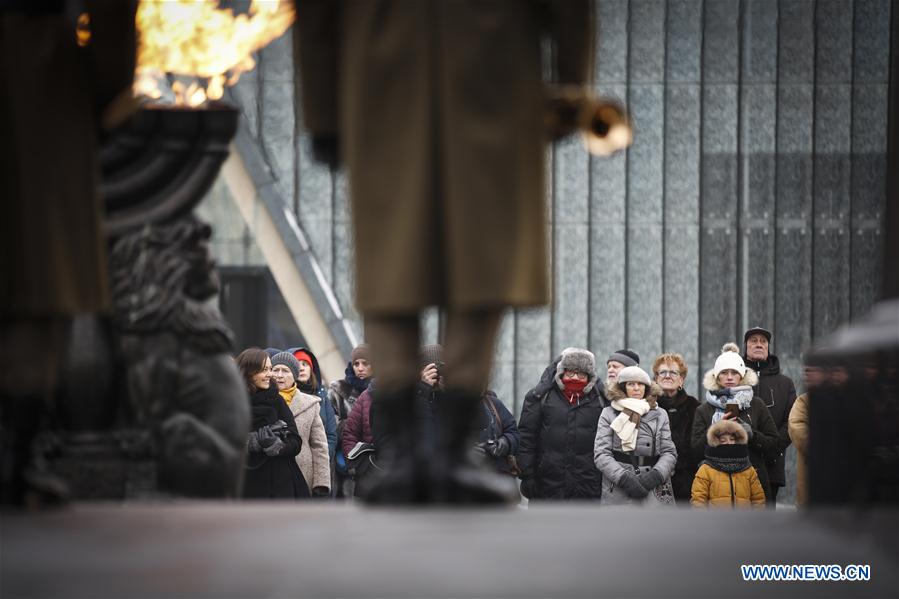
left=691, top=343, right=779, bottom=504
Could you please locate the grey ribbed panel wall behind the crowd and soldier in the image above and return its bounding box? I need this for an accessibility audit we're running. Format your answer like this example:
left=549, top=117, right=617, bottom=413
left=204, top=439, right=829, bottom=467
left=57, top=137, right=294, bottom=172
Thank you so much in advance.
left=202, top=0, right=891, bottom=424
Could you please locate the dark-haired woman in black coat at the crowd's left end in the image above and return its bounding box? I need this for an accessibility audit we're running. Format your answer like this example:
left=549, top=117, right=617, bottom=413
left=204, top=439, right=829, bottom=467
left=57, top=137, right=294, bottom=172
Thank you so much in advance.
left=237, top=347, right=309, bottom=499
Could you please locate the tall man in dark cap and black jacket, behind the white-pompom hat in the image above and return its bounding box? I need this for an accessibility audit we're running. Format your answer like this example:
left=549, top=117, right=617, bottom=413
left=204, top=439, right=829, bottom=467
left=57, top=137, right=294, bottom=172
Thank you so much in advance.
left=743, top=327, right=796, bottom=506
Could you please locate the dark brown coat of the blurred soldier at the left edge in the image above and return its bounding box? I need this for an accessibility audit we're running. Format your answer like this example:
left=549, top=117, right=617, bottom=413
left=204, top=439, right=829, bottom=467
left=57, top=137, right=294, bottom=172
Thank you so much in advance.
left=0, top=0, right=137, bottom=318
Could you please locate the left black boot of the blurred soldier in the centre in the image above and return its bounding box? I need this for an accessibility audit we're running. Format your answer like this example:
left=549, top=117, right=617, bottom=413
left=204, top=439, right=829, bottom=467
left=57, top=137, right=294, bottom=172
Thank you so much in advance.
left=362, top=388, right=429, bottom=505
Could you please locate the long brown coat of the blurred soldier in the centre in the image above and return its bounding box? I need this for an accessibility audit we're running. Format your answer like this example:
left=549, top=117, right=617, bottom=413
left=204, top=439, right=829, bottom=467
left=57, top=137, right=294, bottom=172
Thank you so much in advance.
left=295, top=0, right=593, bottom=313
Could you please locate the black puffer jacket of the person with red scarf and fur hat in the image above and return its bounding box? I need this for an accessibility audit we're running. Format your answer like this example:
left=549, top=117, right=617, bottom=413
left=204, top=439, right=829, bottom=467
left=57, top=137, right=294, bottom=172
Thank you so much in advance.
left=518, top=363, right=608, bottom=499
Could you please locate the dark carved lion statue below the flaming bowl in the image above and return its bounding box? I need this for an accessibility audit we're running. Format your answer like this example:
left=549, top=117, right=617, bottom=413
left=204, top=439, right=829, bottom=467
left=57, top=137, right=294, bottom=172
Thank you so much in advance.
left=110, top=214, right=249, bottom=497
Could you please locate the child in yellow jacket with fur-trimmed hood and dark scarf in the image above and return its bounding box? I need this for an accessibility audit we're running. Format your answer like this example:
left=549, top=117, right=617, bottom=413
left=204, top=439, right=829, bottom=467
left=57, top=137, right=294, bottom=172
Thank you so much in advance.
left=690, top=419, right=765, bottom=508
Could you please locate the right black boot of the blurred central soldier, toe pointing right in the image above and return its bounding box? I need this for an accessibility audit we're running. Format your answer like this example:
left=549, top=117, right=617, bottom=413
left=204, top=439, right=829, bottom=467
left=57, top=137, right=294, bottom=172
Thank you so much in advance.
left=430, top=390, right=520, bottom=505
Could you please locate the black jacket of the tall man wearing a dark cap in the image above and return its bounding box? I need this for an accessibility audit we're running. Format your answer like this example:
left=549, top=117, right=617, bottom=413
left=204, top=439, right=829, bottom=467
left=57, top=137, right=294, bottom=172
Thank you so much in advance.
left=743, top=354, right=796, bottom=487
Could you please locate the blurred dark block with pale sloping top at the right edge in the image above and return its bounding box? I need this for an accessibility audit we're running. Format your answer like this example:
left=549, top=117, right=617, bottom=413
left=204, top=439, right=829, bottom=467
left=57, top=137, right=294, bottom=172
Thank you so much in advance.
left=807, top=299, right=899, bottom=508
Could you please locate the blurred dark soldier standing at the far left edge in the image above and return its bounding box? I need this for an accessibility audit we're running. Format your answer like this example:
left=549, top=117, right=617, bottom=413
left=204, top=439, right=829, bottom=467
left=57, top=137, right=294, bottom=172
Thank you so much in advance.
left=0, top=0, right=137, bottom=505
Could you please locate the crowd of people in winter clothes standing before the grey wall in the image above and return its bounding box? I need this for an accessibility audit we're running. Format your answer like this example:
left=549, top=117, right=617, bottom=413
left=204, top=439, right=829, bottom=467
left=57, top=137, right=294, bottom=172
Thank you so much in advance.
left=237, top=327, right=821, bottom=508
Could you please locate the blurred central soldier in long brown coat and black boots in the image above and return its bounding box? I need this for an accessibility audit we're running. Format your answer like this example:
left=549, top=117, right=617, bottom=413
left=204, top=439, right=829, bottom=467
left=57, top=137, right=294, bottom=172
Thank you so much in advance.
left=294, top=0, right=595, bottom=503
